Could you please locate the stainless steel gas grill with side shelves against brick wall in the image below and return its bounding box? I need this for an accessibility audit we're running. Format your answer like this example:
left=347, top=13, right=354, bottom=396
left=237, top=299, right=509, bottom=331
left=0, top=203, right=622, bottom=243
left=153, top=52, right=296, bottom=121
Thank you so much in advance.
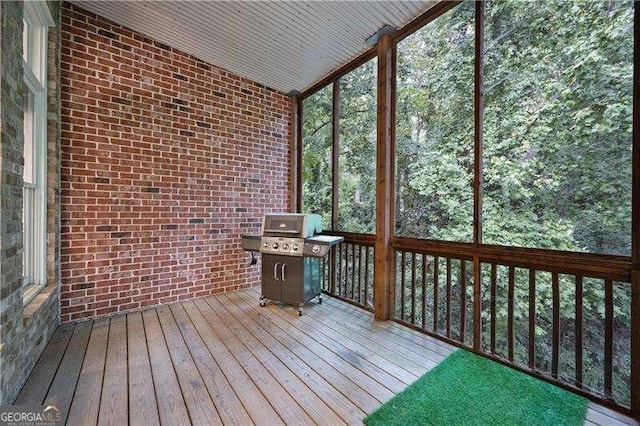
left=242, top=213, right=344, bottom=315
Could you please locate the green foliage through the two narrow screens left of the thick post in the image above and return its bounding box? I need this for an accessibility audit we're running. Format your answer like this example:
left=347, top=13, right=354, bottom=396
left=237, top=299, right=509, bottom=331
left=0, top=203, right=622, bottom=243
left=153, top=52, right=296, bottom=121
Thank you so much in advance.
left=302, top=59, right=377, bottom=234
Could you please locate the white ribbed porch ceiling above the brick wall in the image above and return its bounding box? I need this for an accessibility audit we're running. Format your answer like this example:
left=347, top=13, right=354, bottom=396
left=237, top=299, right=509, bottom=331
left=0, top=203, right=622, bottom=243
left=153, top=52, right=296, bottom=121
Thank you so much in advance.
left=72, top=0, right=436, bottom=93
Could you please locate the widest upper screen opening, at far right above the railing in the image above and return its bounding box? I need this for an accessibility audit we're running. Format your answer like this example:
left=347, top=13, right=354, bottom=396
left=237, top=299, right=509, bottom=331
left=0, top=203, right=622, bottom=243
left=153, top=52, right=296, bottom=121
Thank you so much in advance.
left=482, top=1, right=633, bottom=256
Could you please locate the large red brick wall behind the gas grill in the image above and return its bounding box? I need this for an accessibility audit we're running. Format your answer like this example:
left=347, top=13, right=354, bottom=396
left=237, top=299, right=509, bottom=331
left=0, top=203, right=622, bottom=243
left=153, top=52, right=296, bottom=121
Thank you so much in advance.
left=61, top=3, right=291, bottom=321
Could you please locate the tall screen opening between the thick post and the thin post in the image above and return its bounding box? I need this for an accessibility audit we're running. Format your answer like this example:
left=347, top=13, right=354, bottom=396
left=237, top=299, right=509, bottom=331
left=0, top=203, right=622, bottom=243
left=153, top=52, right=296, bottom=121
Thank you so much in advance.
left=395, top=2, right=474, bottom=241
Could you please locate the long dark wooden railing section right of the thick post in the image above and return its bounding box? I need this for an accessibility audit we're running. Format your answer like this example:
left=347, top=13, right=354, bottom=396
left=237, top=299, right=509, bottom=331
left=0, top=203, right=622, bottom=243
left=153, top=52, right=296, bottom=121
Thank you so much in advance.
left=393, top=239, right=631, bottom=412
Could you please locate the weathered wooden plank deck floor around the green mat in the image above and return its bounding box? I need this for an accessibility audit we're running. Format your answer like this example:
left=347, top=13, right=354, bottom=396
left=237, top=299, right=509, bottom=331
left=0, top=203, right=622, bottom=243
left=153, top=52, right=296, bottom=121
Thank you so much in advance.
left=16, top=289, right=631, bottom=425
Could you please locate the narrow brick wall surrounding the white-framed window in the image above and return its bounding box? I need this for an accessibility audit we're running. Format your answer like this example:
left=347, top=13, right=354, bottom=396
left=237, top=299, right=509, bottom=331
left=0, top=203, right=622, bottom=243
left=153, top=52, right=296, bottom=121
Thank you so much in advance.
left=0, top=2, right=60, bottom=405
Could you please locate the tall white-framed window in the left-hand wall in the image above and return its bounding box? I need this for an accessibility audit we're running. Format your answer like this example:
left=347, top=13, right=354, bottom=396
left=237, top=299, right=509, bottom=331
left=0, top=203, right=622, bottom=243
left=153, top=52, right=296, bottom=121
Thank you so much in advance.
left=22, top=2, right=53, bottom=303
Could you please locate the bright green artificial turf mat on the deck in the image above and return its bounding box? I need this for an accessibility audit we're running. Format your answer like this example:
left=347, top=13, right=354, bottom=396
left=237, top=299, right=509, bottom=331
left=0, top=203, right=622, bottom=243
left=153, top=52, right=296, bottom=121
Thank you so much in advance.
left=364, top=350, right=587, bottom=426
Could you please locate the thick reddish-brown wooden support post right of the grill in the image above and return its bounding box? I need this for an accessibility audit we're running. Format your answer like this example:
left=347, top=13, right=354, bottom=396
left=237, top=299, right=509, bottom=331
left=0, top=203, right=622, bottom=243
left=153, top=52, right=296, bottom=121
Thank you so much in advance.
left=373, top=35, right=396, bottom=320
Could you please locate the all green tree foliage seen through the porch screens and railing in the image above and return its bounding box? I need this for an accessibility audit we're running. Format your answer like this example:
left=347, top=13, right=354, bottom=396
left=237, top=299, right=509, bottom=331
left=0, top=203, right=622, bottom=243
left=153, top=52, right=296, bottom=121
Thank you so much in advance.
left=303, top=0, right=634, bottom=404
